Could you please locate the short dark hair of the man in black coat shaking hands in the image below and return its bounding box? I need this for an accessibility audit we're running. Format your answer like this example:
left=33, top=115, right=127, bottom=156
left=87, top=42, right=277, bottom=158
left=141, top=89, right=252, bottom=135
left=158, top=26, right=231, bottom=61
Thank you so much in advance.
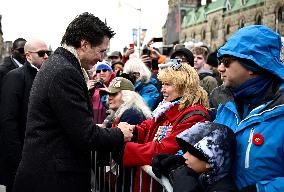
left=61, top=12, right=115, bottom=48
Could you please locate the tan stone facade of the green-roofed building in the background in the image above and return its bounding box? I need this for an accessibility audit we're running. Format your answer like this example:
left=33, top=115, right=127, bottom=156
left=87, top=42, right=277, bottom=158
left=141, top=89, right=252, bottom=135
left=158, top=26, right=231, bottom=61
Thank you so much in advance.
left=164, top=0, right=284, bottom=51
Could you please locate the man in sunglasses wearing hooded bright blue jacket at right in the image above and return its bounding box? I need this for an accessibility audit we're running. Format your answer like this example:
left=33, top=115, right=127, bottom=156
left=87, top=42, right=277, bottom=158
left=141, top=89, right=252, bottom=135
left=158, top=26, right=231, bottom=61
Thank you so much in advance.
left=211, top=25, right=284, bottom=192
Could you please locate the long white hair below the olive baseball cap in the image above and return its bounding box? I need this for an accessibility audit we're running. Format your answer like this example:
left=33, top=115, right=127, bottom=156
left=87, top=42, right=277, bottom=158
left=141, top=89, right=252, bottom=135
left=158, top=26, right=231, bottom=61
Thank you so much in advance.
left=114, top=90, right=152, bottom=119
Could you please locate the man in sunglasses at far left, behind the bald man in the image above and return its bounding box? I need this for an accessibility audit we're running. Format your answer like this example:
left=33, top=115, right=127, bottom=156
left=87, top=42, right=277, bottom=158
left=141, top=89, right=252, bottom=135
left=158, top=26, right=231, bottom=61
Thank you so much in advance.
left=0, top=38, right=27, bottom=84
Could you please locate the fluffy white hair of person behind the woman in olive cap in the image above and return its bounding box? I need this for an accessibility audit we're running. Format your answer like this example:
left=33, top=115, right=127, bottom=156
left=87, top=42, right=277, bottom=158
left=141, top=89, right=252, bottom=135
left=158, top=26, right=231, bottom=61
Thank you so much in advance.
left=123, top=58, right=151, bottom=83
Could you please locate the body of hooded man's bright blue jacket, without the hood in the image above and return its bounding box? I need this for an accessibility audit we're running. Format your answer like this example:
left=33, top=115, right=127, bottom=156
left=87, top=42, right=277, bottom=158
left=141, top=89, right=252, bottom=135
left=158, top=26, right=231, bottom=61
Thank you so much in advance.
left=214, top=83, right=284, bottom=192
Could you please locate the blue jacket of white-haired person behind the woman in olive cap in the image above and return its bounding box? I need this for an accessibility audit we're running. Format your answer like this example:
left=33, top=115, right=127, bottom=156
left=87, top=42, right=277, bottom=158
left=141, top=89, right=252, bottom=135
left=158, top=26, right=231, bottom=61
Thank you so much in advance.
left=134, top=78, right=160, bottom=111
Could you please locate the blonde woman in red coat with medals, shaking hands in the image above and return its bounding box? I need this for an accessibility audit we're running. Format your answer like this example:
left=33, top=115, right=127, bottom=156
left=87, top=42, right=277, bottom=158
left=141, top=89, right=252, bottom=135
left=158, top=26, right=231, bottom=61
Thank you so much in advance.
left=118, top=60, right=209, bottom=191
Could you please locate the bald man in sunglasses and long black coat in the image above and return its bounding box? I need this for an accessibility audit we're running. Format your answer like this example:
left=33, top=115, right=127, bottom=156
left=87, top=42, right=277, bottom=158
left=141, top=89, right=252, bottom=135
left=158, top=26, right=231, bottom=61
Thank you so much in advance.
left=0, top=39, right=50, bottom=192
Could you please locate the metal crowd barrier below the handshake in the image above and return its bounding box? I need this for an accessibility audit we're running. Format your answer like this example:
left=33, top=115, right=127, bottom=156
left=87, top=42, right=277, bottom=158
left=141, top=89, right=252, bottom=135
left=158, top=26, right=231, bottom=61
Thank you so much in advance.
left=91, top=152, right=173, bottom=192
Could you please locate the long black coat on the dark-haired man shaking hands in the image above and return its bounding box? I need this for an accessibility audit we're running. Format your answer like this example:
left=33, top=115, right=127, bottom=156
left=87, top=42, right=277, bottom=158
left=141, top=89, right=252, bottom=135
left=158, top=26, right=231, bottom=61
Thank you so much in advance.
left=14, top=48, right=123, bottom=192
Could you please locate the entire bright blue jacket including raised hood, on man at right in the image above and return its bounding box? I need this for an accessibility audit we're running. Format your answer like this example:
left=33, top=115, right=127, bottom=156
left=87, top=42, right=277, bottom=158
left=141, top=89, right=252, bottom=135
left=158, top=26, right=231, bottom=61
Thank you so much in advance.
left=215, top=25, right=284, bottom=192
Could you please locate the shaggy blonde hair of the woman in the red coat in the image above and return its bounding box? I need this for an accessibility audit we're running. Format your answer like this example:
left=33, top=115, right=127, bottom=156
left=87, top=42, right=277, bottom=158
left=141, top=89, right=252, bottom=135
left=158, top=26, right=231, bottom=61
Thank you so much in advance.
left=158, top=63, right=209, bottom=110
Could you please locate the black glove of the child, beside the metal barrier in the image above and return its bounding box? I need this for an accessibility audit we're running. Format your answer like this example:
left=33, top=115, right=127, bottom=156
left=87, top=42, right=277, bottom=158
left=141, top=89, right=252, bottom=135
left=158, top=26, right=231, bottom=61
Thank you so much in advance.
left=152, top=154, right=185, bottom=178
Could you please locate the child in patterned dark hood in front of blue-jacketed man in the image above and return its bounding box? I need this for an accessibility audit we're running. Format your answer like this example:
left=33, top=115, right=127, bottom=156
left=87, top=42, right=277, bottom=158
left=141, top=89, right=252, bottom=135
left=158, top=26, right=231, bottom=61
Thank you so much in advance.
left=152, top=122, right=237, bottom=192
